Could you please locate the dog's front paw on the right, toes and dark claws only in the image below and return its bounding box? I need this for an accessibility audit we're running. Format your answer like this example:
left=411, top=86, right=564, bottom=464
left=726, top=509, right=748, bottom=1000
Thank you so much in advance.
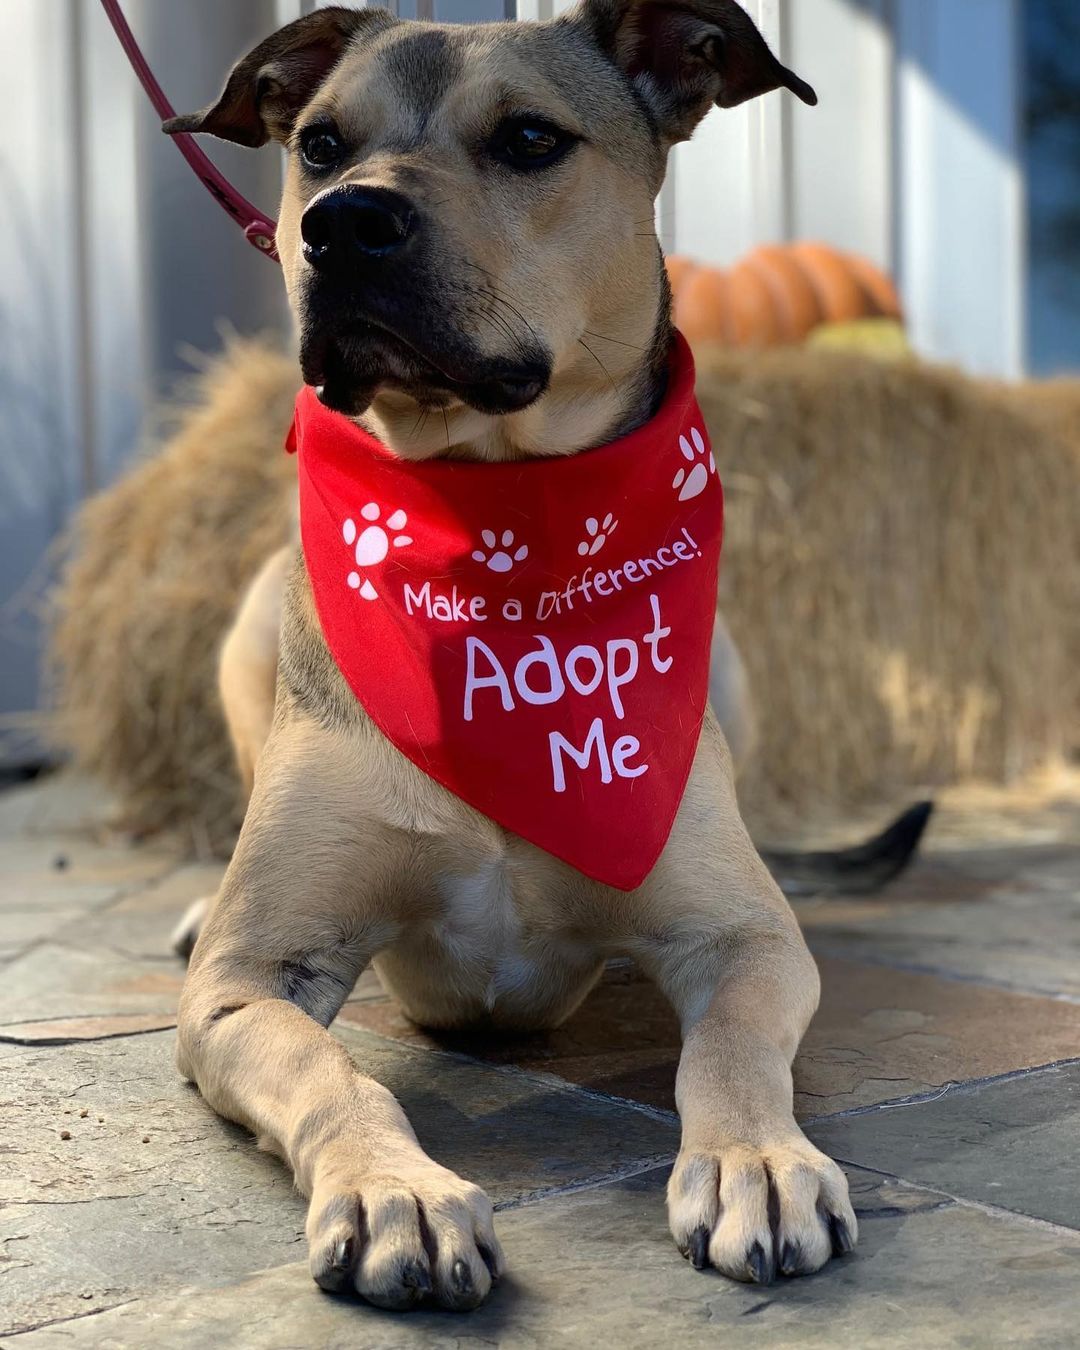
left=667, top=1135, right=859, bottom=1284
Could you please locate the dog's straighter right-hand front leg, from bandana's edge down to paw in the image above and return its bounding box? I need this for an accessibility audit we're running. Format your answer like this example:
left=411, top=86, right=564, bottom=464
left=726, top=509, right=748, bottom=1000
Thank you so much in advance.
left=639, top=724, right=857, bottom=1284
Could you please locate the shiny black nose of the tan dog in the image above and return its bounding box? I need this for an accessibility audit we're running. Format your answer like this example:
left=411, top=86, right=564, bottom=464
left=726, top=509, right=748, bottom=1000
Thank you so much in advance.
left=300, top=188, right=414, bottom=270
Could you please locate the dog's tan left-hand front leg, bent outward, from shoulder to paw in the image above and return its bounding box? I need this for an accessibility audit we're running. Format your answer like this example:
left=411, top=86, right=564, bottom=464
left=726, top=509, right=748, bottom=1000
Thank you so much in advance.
left=178, top=717, right=501, bottom=1308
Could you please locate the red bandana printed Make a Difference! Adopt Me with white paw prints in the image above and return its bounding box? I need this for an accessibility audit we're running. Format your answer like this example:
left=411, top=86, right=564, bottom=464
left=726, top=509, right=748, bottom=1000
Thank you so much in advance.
left=289, top=338, right=724, bottom=891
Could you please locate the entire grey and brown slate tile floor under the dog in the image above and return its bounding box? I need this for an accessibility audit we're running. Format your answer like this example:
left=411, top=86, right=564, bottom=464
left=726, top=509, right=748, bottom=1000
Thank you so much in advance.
left=0, top=780, right=1080, bottom=1350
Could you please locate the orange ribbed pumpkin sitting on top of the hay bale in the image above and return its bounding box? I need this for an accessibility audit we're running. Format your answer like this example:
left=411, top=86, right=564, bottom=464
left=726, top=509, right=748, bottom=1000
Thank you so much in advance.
left=667, top=242, right=902, bottom=347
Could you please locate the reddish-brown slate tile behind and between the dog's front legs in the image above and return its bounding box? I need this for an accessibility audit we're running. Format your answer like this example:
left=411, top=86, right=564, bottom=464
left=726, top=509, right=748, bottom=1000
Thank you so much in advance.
left=342, top=957, right=1080, bottom=1121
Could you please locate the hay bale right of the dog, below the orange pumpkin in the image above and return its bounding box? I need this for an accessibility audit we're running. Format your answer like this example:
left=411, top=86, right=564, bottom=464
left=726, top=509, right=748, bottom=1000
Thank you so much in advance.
left=698, top=351, right=1080, bottom=828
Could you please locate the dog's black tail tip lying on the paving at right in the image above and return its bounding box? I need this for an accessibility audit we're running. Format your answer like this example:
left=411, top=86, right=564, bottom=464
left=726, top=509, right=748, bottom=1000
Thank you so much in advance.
left=761, top=802, right=934, bottom=896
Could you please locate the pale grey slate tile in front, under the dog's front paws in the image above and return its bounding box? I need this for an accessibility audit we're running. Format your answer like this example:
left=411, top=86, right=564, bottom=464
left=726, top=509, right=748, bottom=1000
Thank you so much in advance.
left=14, top=1172, right=1080, bottom=1350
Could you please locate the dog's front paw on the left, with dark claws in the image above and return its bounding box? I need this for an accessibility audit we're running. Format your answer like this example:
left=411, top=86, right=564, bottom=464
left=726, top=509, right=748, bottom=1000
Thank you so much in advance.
left=308, top=1158, right=504, bottom=1311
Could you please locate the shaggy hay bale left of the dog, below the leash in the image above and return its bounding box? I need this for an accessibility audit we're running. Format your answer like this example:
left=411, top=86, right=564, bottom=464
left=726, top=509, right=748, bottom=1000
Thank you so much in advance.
left=50, top=342, right=298, bottom=852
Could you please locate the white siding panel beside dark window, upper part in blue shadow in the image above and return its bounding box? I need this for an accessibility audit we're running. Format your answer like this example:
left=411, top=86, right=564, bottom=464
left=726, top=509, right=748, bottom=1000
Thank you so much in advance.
left=896, top=0, right=1026, bottom=377
